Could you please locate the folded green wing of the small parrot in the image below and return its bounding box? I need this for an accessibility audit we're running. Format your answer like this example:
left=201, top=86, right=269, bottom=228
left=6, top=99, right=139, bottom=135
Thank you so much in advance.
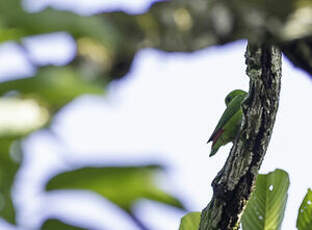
left=207, top=95, right=246, bottom=143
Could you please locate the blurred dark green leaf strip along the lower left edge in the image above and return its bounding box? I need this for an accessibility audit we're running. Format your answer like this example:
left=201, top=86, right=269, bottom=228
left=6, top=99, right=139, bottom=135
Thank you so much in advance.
left=0, top=138, right=20, bottom=224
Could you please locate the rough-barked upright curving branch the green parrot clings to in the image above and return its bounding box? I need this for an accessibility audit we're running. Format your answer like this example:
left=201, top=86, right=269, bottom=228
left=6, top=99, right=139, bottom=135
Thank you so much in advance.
left=199, top=44, right=281, bottom=230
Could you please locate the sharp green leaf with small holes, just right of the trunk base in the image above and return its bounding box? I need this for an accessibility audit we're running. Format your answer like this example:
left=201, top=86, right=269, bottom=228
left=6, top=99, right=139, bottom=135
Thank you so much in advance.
left=242, top=169, right=289, bottom=230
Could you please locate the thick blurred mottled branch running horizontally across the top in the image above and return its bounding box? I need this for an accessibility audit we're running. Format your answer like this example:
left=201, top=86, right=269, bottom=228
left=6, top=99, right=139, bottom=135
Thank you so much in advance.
left=100, top=0, right=294, bottom=52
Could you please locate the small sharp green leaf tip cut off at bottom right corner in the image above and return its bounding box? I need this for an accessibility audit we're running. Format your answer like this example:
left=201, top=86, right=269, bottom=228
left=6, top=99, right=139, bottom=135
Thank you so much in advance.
left=296, top=189, right=312, bottom=230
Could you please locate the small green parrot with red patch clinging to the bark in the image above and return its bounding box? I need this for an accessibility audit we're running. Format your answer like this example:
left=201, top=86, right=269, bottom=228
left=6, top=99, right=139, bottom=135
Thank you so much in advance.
left=207, top=89, right=247, bottom=157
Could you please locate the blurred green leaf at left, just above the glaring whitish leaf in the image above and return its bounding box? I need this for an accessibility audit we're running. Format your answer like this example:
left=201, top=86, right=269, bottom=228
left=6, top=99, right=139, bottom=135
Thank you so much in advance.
left=0, top=67, right=104, bottom=111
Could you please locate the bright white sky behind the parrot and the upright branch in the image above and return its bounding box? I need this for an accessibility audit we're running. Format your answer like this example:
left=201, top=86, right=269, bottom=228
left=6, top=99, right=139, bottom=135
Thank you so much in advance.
left=0, top=0, right=312, bottom=230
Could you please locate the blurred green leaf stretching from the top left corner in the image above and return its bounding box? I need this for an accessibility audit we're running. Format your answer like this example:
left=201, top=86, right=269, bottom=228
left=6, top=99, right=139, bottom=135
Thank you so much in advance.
left=0, top=0, right=120, bottom=48
